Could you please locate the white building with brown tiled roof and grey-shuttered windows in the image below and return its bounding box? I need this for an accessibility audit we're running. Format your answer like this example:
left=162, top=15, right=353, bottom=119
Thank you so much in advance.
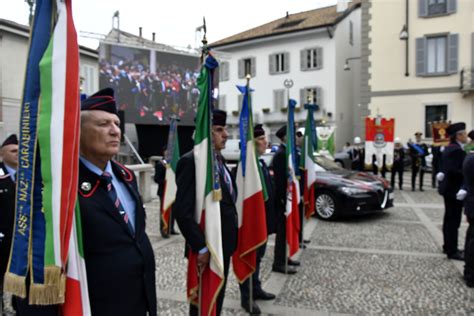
left=211, top=1, right=361, bottom=149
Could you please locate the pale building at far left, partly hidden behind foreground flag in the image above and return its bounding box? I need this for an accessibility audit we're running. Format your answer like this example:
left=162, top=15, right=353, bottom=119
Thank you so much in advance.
left=0, top=19, right=99, bottom=142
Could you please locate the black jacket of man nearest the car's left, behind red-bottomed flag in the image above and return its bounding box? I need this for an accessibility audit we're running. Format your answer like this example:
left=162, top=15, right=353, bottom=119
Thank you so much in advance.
left=272, top=144, right=288, bottom=217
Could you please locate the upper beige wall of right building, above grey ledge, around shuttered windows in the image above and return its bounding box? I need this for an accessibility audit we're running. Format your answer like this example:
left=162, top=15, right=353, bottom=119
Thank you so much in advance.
left=369, top=0, right=474, bottom=91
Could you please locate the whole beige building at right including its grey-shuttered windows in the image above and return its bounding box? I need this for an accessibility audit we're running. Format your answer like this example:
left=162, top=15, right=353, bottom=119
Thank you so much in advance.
left=361, top=0, right=474, bottom=141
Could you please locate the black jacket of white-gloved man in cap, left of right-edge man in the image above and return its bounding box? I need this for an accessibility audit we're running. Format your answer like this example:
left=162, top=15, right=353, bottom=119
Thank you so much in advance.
left=439, top=142, right=466, bottom=198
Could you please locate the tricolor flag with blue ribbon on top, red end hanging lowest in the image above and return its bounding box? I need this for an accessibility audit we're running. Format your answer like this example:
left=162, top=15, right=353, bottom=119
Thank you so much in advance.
left=232, top=86, right=267, bottom=282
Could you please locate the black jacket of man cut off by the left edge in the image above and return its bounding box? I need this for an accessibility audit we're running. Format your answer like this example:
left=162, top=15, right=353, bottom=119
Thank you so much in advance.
left=0, top=162, right=16, bottom=280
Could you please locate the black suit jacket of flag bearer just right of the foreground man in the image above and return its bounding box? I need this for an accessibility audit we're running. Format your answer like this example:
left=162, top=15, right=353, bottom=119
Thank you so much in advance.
left=173, top=151, right=237, bottom=257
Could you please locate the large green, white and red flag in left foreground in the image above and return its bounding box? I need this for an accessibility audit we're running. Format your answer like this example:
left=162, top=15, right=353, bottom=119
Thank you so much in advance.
left=38, top=0, right=90, bottom=315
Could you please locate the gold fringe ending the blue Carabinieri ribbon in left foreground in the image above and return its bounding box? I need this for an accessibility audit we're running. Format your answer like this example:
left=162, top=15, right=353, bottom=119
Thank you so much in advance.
left=29, top=266, right=66, bottom=305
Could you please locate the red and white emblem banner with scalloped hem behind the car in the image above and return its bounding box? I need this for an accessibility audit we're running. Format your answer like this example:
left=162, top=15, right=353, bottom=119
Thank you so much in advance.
left=364, top=116, right=395, bottom=170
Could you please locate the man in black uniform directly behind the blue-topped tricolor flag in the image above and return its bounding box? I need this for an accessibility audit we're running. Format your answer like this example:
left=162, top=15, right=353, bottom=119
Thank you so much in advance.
left=240, top=124, right=276, bottom=314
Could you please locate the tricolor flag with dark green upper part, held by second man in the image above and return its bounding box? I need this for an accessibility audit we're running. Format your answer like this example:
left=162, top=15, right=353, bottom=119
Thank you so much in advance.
left=187, top=55, right=224, bottom=316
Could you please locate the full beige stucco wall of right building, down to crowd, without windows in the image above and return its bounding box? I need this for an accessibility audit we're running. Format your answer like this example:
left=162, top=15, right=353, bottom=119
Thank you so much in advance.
left=369, top=0, right=474, bottom=142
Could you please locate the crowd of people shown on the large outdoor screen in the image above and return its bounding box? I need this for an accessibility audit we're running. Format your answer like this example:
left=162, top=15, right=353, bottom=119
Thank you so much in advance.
left=99, top=60, right=199, bottom=124
